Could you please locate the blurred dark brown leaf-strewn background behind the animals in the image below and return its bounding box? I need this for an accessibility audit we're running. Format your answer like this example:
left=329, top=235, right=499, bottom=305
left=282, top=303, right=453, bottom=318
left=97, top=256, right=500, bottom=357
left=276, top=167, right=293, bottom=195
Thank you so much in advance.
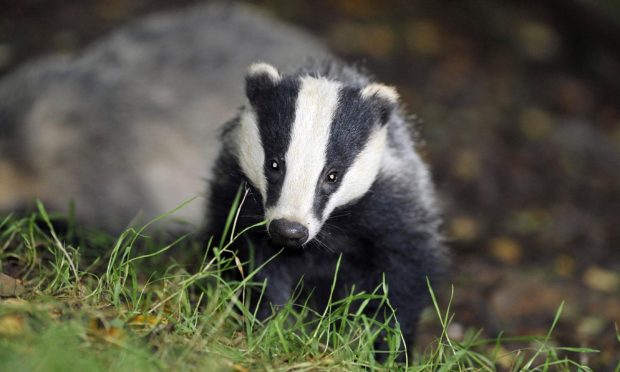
left=0, top=0, right=620, bottom=366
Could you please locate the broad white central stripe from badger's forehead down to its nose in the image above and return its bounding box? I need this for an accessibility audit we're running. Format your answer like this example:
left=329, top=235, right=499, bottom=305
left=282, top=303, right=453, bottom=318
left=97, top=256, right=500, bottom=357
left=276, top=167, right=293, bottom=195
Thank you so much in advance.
left=261, top=77, right=340, bottom=239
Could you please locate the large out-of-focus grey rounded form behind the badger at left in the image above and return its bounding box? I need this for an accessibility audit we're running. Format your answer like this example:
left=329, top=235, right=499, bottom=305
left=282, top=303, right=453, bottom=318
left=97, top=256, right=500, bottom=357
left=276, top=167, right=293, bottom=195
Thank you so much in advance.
left=0, top=3, right=328, bottom=233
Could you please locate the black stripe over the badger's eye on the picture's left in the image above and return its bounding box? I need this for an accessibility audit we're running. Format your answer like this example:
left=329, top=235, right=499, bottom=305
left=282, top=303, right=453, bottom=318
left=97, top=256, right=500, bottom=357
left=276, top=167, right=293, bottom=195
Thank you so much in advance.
left=252, top=79, right=299, bottom=207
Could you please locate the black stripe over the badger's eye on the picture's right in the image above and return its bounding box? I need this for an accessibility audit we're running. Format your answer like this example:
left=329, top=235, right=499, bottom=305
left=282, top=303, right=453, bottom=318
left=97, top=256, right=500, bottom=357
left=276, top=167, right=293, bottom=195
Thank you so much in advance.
left=313, top=87, right=378, bottom=218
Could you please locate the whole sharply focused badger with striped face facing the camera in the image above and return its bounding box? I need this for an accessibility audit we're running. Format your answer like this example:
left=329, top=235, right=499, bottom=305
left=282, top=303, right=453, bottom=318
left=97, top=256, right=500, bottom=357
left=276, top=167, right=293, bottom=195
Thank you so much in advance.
left=206, top=60, right=446, bottom=354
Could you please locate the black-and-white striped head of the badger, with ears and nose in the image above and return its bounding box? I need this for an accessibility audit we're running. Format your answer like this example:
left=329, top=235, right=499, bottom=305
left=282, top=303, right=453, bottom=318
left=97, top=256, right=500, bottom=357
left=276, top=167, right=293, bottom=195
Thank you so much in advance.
left=236, top=63, right=398, bottom=247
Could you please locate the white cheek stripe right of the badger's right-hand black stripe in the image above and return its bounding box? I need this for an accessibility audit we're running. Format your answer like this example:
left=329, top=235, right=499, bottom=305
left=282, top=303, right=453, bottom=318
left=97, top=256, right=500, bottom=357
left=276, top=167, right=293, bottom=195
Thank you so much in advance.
left=322, top=126, right=387, bottom=222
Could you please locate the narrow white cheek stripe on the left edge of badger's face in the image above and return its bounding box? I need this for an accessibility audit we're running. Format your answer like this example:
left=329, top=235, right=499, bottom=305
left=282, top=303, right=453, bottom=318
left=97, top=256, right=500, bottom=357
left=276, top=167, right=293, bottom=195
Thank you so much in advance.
left=236, top=108, right=267, bottom=200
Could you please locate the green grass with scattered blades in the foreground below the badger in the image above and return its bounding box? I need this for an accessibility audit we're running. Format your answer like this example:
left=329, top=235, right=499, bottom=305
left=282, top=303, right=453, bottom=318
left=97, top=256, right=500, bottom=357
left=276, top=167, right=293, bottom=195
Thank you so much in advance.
left=0, top=201, right=604, bottom=372
